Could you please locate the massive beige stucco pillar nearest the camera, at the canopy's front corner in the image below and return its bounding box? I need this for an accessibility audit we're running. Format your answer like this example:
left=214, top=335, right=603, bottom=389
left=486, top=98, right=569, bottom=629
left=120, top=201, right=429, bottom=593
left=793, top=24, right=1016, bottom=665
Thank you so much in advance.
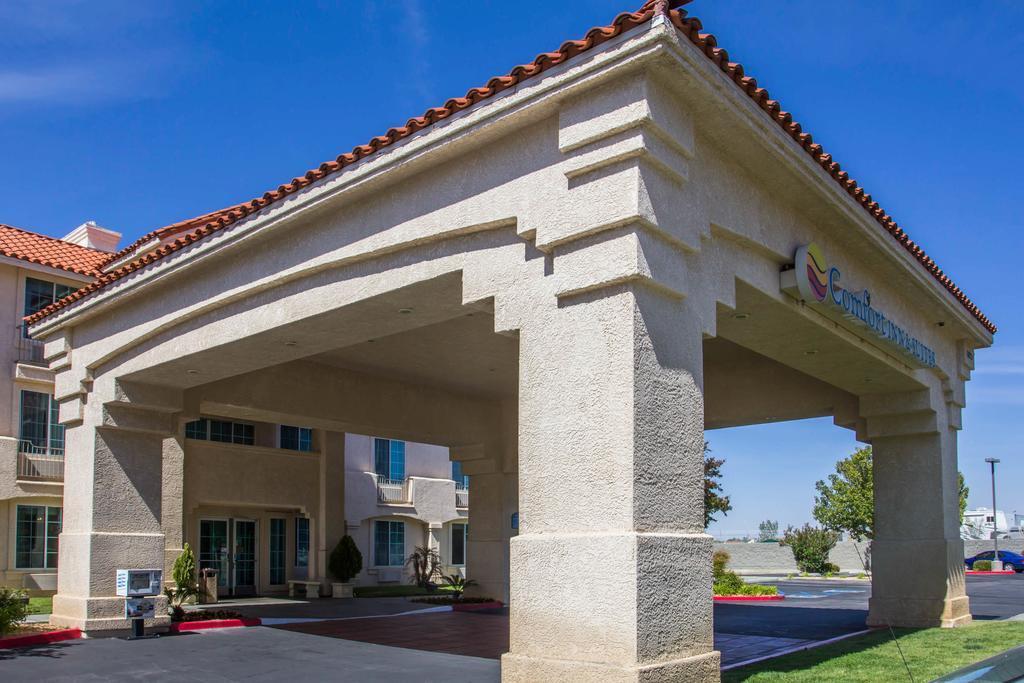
left=499, top=286, right=720, bottom=683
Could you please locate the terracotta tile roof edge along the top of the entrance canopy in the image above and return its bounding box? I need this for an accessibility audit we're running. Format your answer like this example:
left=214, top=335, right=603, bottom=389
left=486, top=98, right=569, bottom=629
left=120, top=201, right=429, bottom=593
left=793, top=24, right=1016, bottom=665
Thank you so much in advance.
left=27, top=0, right=996, bottom=333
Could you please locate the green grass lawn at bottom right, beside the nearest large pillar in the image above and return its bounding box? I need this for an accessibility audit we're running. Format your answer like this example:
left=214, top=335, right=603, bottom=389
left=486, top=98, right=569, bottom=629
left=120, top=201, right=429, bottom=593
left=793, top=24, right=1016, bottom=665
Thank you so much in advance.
left=722, top=622, right=1024, bottom=683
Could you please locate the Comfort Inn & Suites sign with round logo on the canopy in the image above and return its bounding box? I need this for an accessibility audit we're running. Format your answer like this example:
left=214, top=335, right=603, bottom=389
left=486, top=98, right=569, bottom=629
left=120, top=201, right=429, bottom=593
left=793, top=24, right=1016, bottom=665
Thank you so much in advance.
left=781, top=244, right=935, bottom=368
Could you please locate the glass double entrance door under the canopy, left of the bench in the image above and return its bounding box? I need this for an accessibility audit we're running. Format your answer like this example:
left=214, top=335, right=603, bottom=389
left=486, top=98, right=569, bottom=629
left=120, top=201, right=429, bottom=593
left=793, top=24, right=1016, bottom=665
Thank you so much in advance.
left=199, top=519, right=259, bottom=595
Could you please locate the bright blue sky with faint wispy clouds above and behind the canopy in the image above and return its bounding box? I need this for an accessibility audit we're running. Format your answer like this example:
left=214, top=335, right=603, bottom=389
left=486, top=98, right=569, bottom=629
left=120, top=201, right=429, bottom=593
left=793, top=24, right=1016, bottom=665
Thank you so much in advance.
left=0, top=0, right=1024, bottom=535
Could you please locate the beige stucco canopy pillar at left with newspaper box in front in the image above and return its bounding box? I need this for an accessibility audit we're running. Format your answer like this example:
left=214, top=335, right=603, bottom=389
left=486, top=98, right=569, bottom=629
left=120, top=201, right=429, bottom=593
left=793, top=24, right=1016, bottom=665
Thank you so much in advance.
left=50, top=401, right=175, bottom=633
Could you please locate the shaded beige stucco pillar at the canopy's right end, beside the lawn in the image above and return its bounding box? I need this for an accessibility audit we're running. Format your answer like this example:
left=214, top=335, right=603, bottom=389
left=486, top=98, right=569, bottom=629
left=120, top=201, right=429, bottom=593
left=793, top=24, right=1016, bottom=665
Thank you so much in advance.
left=867, top=392, right=971, bottom=627
